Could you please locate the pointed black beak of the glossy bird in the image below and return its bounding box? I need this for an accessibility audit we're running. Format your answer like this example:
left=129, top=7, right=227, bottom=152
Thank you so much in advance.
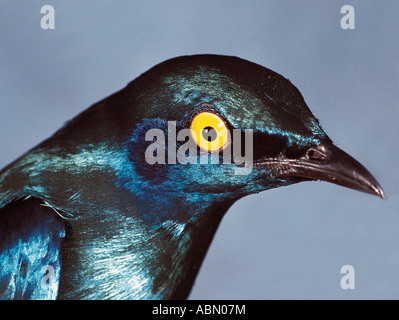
left=255, top=142, right=385, bottom=199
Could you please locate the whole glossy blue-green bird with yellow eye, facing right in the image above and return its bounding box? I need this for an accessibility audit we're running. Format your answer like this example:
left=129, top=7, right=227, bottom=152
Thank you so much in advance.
left=0, top=54, right=384, bottom=300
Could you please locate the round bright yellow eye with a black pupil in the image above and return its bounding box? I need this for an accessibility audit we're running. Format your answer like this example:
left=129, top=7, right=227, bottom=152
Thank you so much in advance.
left=191, top=112, right=229, bottom=151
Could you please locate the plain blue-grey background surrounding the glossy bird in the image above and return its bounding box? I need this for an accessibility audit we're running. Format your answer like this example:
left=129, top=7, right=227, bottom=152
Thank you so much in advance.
left=0, top=0, right=399, bottom=299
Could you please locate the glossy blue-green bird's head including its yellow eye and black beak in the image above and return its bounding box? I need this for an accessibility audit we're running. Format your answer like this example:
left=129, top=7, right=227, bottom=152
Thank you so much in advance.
left=122, top=55, right=383, bottom=220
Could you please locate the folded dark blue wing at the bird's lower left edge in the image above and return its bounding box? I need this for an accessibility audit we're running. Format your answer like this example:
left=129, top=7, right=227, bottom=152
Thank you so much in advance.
left=0, top=198, right=65, bottom=300
